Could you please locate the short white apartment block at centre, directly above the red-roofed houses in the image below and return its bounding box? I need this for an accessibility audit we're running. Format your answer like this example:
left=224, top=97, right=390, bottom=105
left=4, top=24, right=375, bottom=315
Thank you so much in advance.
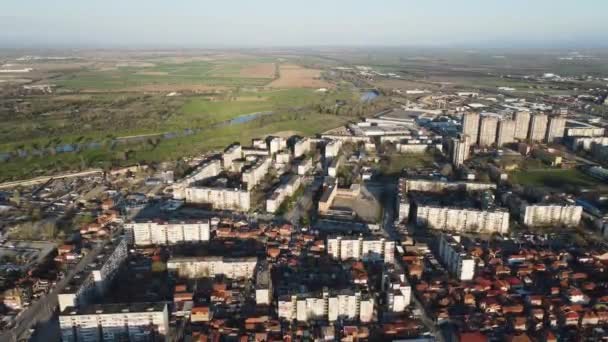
left=327, top=236, right=395, bottom=263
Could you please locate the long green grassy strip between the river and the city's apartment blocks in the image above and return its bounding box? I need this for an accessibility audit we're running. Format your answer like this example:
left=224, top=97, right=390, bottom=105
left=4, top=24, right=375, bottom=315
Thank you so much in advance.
left=0, top=113, right=348, bottom=181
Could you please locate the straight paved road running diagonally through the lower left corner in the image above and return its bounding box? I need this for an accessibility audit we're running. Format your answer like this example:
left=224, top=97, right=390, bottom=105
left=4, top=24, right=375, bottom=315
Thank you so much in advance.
left=0, top=243, right=104, bottom=341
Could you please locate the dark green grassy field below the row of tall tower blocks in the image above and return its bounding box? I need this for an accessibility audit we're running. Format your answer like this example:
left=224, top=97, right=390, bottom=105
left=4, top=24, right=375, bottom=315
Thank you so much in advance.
left=510, top=169, right=603, bottom=191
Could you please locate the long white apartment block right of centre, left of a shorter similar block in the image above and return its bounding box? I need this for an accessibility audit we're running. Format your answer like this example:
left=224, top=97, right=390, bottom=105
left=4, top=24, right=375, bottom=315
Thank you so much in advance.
left=416, top=205, right=509, bottom=234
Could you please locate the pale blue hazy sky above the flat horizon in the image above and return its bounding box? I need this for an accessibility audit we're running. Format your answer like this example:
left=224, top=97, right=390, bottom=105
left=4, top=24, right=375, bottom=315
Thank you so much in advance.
left=0, top=0, right=608, bottom=48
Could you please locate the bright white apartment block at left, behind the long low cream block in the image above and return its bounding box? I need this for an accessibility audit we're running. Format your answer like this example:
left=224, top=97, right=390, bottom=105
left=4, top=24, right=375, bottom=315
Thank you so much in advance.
left=125, top=220, right=210, bottom=246
